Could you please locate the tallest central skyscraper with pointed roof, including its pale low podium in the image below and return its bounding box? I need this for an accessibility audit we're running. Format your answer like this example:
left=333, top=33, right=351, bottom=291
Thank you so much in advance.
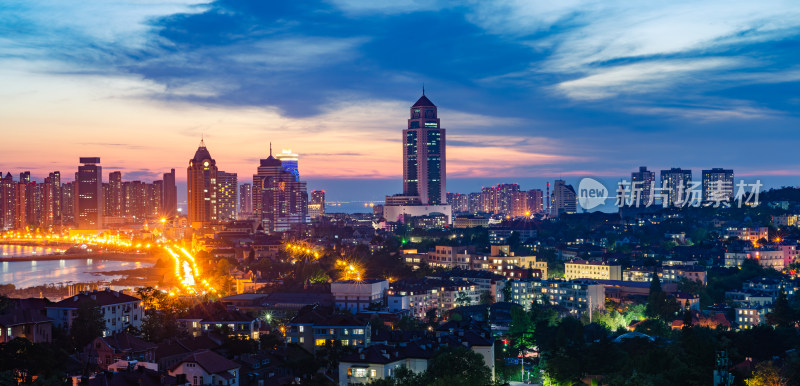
left=383, top=90, right=452, bottom=222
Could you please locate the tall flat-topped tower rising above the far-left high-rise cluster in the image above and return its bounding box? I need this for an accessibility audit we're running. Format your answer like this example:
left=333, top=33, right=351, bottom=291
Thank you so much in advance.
left=75, top=157, right=103, bottom=229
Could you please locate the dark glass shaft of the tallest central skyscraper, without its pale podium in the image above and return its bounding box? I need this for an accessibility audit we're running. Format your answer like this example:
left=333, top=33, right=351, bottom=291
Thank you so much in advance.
left=403, top=92, right=447, bottom=205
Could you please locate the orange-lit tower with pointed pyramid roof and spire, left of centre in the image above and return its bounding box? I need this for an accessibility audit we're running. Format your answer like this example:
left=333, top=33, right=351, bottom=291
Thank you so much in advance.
left=186, top=140, right=217, bottom=227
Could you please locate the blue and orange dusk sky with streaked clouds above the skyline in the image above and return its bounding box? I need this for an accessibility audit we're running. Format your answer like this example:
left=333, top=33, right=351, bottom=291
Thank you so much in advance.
left=0, top=0, right=800, bottom=210
